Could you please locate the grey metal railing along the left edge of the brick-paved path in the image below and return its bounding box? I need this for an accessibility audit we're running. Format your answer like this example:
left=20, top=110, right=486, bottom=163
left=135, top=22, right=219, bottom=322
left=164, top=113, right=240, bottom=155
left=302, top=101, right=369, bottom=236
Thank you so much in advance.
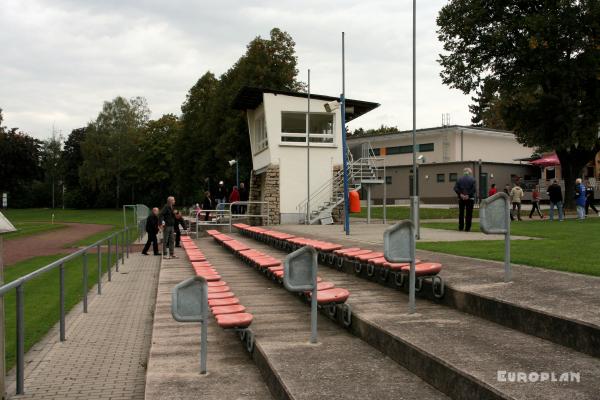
left=0, top=227, right=135, bottom=394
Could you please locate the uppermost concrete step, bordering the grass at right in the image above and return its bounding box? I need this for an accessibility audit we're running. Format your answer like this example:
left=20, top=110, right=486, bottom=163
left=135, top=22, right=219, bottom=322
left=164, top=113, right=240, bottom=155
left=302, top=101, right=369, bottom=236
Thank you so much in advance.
left=279, top=226, right=600, bottom=357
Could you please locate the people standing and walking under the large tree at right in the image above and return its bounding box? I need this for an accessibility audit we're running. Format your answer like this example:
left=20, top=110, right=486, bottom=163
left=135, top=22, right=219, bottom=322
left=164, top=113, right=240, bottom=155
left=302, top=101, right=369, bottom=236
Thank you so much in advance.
left=454, top=168, right=600, bottom=232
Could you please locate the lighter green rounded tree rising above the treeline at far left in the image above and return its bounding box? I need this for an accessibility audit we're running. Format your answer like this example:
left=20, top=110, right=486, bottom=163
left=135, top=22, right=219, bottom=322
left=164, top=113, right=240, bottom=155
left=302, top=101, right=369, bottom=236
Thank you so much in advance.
left=80, top=96, right=150, bottom=208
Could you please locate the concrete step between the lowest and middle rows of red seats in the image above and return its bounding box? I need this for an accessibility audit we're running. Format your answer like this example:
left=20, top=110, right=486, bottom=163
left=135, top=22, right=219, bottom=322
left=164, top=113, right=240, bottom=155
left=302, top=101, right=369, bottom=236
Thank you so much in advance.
left=197, top=239, right=447, bottom=400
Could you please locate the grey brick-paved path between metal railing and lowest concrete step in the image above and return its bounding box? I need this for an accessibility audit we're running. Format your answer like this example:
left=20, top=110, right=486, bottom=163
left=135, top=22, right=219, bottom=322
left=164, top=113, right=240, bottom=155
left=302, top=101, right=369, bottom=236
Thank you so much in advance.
left=7, top=254, right=160, bottom=400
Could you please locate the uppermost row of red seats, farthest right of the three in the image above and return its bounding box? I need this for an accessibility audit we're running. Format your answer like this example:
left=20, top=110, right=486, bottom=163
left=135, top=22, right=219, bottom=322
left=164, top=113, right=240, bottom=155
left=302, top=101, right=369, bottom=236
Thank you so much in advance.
left=233, top=223, right=444, bottom=298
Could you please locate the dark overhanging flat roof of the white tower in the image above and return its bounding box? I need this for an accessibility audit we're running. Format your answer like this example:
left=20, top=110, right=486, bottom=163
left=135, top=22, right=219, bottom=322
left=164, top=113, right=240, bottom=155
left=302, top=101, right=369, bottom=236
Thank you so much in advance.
left=232, top=86, right=379, bottom=121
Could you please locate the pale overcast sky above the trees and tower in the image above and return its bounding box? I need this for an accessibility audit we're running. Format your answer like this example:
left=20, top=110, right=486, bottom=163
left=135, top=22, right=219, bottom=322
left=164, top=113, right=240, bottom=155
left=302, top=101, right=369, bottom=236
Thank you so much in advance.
left=0, top=0, right=470, bottom=138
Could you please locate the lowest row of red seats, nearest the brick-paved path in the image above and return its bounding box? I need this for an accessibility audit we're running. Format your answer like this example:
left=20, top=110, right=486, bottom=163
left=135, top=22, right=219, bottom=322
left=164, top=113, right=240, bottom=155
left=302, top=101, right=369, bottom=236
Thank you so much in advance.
left=181, top=236, right=253, bottom=330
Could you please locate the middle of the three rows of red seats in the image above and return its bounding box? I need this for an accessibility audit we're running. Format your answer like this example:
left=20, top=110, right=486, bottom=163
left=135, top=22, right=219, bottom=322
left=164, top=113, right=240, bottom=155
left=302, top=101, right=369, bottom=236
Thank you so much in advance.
left=206, top=230, right=350, bottom=307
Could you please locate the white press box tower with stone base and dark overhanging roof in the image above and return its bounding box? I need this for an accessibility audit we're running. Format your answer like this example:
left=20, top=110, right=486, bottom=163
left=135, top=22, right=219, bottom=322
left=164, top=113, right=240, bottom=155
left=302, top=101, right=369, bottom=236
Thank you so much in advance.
left=233, top=87, right=379, bottom=224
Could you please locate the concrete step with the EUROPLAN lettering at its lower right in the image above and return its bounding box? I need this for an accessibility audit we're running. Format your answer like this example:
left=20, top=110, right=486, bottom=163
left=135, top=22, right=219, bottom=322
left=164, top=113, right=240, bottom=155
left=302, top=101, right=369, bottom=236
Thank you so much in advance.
left=241, top=236, right=600, bottom=399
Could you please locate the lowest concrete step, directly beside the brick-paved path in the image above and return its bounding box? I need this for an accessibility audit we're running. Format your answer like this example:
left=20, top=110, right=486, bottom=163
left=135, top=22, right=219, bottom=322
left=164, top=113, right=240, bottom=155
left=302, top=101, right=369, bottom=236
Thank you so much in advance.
left=144, top=253, right=273, bottom=400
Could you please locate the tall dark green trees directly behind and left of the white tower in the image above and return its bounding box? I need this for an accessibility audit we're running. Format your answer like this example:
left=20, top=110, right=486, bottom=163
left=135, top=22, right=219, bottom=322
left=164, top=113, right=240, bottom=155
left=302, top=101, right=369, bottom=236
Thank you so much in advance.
left=177, top=28, right=304, bottom=201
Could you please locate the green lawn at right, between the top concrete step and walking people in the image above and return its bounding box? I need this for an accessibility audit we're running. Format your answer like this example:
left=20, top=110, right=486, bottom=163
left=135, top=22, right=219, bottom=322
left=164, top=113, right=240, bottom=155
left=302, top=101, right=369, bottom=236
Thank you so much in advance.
left=418, top=218, right=600, bottom=276
